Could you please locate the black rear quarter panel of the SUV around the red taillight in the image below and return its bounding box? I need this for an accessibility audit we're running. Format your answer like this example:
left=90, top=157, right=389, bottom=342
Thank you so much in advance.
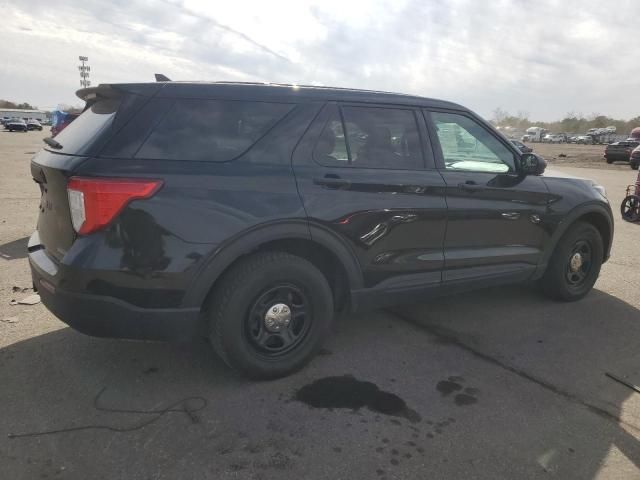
left=68, top=106, right=319, bottom=307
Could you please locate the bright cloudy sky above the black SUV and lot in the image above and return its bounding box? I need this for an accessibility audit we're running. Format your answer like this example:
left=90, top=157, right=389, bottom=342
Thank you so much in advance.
left=0, top=0, right=640, bottom=121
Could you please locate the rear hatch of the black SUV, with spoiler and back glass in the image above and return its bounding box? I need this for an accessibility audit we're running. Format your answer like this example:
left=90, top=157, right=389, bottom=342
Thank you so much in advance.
left=31, top=85, right=155, bottom=260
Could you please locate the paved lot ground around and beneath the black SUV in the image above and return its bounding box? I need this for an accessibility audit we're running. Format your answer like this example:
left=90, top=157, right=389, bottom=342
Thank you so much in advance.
left=0, top=131, right=640, bottom=479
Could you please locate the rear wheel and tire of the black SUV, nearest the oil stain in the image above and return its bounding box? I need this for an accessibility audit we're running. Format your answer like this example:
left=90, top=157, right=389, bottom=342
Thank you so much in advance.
left=207, top=252, right=333, bottom=380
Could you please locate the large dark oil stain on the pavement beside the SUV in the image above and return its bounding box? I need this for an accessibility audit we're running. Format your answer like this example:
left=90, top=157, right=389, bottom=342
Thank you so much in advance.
left=294, top=375, right=421, bottom=423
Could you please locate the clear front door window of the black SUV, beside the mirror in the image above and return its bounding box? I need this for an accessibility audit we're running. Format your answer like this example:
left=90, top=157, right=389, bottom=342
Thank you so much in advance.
left=431, top=112, right=514, bottom=173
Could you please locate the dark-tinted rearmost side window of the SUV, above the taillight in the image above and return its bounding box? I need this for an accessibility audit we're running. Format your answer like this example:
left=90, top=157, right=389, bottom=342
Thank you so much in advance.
left=136, top=99, right=293, bottom=162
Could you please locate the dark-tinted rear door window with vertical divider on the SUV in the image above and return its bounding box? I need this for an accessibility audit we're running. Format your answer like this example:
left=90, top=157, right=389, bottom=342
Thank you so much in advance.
left=313, top=107, right=424, bottom=169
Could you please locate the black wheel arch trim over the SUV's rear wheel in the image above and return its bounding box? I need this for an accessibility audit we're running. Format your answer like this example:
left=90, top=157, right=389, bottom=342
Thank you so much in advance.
left=183, top=221, right=363, bottom=307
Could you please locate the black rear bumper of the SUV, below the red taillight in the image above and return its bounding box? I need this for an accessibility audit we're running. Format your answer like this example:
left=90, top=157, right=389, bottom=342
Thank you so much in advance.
left=29, top=233, right=204, bottom=341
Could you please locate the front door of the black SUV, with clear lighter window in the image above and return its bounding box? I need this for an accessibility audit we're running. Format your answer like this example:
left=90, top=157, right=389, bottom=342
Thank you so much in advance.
left=425, top=110, right=549, bottom=282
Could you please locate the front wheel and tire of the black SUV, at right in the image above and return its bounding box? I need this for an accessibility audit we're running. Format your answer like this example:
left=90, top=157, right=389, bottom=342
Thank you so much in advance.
left=540, top=222, right=604, bottom=302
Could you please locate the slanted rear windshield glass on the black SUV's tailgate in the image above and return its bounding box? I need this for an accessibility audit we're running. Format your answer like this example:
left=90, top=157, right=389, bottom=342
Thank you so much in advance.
left=54, top=99, right=120, bottom=155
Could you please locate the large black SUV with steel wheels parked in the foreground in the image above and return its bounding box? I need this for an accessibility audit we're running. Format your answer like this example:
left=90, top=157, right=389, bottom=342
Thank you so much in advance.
left=28, top=82, right=613, bottom=378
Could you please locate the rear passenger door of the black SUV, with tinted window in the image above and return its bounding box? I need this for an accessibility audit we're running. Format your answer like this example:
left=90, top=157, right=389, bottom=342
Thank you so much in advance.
left=293, top=103, right=446, bottom=289
